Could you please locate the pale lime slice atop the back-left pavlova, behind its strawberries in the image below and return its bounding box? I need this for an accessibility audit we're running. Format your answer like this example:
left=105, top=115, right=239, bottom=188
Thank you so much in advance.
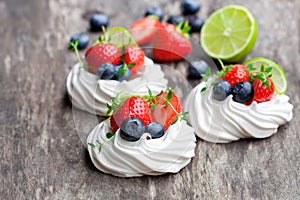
left=106, top=27, right=137, bottom=47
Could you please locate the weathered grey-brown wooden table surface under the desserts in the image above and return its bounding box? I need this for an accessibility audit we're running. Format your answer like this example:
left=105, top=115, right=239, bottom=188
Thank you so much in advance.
left=0, top=0, right=300, bottom=199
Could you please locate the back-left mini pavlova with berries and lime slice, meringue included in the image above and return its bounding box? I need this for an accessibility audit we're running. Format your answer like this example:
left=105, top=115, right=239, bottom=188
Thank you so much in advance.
left=66, top=27, right=167, bottom=116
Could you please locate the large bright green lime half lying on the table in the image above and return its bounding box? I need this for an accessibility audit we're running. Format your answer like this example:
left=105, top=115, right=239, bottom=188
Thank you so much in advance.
left=200, top=5, right=257, bottom=62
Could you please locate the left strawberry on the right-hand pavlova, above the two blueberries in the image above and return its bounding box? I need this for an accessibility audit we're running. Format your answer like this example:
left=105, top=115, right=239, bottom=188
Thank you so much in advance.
left=222, top=65, right=250, bottom=87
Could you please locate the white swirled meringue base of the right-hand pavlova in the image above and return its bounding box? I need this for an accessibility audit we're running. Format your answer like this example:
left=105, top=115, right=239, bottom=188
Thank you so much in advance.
left=184, top=83, right=293, bottom=143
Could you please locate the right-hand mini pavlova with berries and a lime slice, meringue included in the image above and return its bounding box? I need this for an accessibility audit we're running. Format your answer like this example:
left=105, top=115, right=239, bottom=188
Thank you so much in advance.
left=184, top=58, right=293, bottom=143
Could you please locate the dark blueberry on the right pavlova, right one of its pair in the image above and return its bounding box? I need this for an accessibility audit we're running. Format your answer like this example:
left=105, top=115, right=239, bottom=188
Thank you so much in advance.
left=232, top=81, right=254, bottom=103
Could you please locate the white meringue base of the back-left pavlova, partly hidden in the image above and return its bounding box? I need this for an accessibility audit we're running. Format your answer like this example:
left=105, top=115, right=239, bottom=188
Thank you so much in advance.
left=66, top=57, right=168, bottom=115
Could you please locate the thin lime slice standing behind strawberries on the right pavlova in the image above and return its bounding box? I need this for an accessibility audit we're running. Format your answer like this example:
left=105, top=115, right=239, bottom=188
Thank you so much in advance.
left=243, top=58, right=288, bottom=94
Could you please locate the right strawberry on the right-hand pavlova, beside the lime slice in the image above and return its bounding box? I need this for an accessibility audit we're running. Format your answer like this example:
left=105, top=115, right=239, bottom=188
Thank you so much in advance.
left=252, top=78, right=274, bottom=103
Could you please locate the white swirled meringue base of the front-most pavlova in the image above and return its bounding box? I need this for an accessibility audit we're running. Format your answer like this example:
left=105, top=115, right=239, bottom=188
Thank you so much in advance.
left=87, top=120, right=196, bottom=177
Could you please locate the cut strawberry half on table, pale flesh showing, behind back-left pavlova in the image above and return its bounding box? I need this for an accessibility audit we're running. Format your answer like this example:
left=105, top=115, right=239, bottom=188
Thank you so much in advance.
left=130, top=16, right=161, bottom=44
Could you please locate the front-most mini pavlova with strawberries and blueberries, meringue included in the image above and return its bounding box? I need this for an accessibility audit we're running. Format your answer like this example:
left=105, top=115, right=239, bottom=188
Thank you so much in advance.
left=87, top=89, right=196, bottom=177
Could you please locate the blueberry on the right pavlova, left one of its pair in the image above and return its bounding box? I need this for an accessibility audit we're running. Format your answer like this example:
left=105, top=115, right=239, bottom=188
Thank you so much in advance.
left=212, top=80, right=232, bottom=101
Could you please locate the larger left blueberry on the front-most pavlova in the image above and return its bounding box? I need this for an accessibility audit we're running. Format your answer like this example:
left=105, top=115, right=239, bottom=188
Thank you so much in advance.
left=120, top=118, right=145, bottom=142
